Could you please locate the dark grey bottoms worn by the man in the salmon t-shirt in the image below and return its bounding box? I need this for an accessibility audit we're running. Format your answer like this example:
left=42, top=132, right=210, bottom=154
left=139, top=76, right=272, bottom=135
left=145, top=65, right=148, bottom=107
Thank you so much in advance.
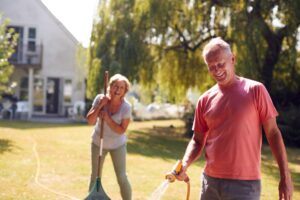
left=200, top=173, right=261, bottom=200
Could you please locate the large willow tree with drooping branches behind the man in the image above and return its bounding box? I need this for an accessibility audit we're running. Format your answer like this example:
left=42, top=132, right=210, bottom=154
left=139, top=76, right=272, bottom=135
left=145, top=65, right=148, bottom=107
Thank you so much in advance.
left=90, top=0, right=300, bottom=104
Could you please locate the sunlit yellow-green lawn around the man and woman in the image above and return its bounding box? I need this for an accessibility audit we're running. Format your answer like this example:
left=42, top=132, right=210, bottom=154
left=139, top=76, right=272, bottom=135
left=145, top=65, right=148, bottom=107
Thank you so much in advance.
left=0, top=120, right=300, bottom=200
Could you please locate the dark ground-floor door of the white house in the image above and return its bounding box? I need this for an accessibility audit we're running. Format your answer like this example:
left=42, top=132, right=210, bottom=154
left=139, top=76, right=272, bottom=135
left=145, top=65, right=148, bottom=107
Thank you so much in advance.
left=46, top=78, right=59, bottom=114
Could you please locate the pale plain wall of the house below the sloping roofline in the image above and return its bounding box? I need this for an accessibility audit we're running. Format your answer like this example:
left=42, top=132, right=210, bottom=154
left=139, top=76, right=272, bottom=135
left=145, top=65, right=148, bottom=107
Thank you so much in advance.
left=0, top=0, right=85, bottom=115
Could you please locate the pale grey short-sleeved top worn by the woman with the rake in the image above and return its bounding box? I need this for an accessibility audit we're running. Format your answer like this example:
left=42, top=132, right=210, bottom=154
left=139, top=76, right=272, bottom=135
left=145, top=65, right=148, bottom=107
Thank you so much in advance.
left=92, top=94, right=131, bottom=149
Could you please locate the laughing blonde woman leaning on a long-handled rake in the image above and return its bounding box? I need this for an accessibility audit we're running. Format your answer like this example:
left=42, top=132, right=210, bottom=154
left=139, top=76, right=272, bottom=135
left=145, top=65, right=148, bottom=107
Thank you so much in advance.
left=87, top=74, right=131, bottom=200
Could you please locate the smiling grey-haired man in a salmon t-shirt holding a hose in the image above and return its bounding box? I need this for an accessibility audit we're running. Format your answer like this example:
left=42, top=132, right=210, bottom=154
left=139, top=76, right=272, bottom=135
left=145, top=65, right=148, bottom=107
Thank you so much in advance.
left=177, top=37, right=293, bottom=200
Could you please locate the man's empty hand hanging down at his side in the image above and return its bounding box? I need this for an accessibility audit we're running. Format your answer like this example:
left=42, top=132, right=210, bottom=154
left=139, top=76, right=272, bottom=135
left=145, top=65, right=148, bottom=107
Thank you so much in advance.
left=278, top=173, right=294, bottom=200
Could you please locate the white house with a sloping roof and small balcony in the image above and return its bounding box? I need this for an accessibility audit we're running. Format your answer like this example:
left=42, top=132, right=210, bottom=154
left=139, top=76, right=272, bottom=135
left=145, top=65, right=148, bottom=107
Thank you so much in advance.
left=0, top=0, right=85, bottom=118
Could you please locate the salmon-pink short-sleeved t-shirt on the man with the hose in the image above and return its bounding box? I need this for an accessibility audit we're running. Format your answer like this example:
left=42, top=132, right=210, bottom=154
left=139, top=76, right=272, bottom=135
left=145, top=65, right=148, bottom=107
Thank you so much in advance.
left=193, top=77, right=278, bottom=180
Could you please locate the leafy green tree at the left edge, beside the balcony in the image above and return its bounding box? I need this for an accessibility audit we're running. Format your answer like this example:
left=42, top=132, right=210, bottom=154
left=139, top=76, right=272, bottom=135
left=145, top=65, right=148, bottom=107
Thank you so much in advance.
left=0, top=14, right=18, bottom=98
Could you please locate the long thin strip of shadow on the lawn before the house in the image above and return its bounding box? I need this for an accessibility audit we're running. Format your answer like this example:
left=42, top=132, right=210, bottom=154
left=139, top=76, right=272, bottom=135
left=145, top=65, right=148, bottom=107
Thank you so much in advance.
left=0, top=120, right=87, bottom=129
